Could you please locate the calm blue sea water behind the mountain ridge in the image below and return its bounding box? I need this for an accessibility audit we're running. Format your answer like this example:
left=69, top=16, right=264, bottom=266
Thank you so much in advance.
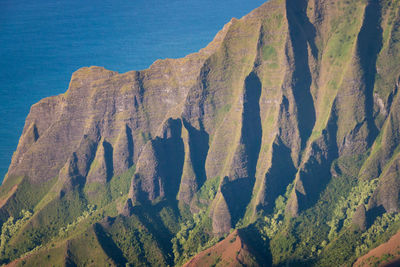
left=0, top=0, right=265, bottom=181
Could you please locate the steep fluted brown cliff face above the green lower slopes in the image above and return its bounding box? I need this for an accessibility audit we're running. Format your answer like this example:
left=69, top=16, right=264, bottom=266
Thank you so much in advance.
left=0, top=0, right=400, bottom=263
